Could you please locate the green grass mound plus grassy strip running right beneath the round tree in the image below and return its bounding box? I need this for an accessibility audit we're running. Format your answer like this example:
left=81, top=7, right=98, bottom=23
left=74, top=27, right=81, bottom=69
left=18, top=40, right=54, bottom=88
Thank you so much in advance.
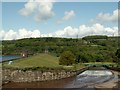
left=2, top=53, right=116, bottom=70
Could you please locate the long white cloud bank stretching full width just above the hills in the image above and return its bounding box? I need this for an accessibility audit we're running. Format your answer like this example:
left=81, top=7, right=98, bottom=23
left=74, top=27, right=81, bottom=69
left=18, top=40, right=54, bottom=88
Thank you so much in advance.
left=0, top=23, right=118, bottom=40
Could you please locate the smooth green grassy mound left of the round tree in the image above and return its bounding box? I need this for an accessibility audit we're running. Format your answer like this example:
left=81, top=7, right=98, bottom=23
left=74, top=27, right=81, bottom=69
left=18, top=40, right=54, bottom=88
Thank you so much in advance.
left=3, top=54, right=59, bottom=68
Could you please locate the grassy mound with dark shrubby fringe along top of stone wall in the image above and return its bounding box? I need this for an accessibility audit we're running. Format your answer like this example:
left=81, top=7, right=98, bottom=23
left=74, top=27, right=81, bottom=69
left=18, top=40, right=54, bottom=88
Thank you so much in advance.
left=0, top=53, right=85, bottom=71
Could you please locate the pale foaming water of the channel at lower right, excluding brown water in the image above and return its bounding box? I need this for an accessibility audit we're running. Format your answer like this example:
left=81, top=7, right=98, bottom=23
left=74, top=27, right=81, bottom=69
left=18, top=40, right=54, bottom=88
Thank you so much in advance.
left=66, top=70, right=115, bottom=88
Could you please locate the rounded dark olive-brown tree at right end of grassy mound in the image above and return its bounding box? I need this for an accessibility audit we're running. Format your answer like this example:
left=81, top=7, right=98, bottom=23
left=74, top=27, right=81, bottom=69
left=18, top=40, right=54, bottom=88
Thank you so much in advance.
left=59, top=51, right=75, bottom=65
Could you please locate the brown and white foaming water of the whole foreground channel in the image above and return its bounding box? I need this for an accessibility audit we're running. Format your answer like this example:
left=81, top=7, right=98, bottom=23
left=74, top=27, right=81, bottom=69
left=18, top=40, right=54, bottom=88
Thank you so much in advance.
left=3, top=70, right=118, bottom=90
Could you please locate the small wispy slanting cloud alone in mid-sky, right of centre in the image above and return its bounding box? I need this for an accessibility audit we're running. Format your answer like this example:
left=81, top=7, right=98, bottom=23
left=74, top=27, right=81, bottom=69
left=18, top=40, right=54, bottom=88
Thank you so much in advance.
left=57, top=10, right=75, bottom=24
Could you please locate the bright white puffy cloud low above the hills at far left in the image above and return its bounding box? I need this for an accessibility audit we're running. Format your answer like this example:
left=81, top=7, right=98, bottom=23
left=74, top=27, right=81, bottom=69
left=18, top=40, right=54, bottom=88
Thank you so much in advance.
left=0, top=28, right=40, bottom=40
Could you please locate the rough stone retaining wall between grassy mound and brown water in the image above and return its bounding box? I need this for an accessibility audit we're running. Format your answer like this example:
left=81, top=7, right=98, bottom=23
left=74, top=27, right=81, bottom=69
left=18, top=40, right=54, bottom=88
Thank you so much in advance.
left=2, top=69, right=76, bottom=84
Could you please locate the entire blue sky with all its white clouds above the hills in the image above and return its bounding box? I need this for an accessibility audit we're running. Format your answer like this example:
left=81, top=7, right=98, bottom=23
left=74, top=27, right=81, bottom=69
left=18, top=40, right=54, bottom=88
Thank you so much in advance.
left=0, top=0, right=119, bottom=40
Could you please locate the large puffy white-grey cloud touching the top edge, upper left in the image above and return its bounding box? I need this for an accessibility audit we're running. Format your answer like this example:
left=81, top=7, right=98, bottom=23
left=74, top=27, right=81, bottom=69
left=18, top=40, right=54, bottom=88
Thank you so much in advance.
left=19, top=0, right=55, bottom=22
